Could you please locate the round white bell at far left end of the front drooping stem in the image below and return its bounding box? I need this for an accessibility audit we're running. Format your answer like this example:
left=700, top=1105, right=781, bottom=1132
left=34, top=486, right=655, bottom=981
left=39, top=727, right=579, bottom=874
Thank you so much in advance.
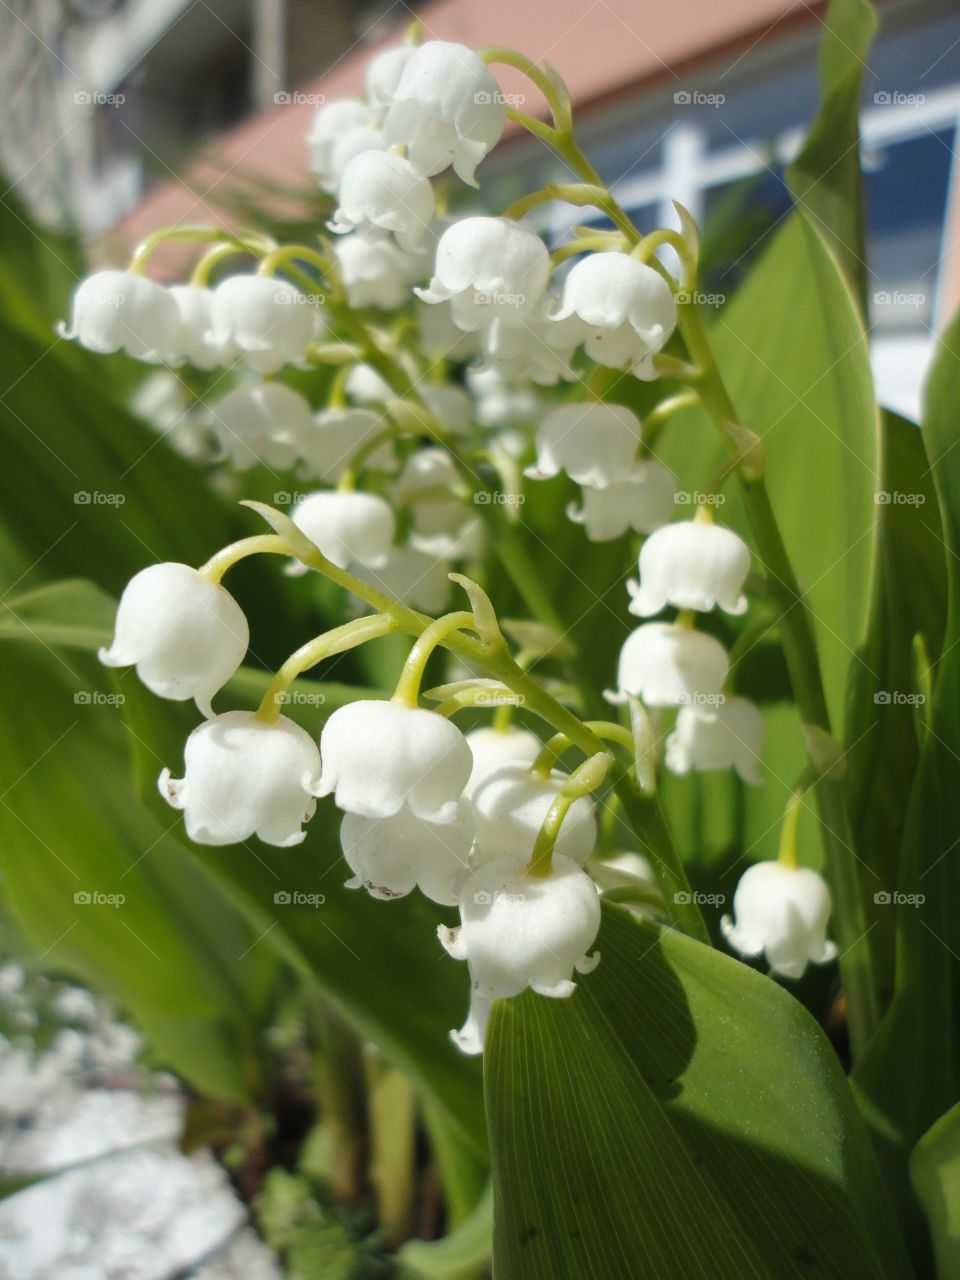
left=97, top=563, right=250, bottom=716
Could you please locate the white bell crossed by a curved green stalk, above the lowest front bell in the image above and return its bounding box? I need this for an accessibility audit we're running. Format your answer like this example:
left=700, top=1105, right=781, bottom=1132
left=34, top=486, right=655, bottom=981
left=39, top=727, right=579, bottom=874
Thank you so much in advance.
left=470, top=760, right=596, bottom=867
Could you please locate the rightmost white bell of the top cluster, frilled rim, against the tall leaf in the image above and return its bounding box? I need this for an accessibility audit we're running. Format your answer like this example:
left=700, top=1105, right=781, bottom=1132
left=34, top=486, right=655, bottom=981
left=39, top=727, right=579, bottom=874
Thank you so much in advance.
left=553, top=252, right=677, bottom=380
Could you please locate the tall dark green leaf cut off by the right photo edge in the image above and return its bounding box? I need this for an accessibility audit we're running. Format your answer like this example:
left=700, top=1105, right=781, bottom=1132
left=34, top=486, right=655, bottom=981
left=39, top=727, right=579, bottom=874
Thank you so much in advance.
left=856, top=307, right=960, bottom=1247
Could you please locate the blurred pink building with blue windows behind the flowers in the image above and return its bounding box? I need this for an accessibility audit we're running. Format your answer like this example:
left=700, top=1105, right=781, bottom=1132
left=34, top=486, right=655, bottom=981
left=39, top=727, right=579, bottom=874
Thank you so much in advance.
left=0, top=0, right=960, bottom=413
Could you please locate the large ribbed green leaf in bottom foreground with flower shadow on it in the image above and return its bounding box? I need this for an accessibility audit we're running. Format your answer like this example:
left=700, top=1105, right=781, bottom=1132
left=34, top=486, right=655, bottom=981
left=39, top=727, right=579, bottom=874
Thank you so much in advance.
left=485, top=905, right=910, bottom=1280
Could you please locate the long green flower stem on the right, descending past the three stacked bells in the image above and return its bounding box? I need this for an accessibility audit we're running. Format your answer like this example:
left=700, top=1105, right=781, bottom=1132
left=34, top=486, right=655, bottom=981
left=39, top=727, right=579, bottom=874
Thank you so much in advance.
left=680, top=301, right=879, bottom=1055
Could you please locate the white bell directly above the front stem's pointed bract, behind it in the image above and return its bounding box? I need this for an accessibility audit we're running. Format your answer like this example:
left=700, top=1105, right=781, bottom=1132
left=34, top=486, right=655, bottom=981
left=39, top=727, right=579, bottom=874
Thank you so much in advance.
left=291, top=492, right=397, bottom=573
